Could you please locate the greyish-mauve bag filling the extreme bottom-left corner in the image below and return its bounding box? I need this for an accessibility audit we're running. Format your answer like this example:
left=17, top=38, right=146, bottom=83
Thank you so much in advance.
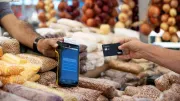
left=0, top=90, right=30, bottom=101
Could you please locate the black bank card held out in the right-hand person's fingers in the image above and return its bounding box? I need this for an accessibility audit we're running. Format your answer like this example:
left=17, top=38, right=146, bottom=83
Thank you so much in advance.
left=102, top=43, right=123, bottom=57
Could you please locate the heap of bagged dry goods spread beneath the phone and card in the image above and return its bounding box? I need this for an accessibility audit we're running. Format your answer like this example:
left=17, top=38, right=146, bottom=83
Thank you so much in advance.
left=0, top=32, right=180, bottom=101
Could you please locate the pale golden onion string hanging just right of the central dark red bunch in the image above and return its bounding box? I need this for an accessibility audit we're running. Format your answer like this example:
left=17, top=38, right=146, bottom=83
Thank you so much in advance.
left=115, top=0, right=139, bottom=31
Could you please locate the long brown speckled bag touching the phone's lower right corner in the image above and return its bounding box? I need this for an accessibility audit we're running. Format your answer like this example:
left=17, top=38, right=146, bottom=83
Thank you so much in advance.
left=79, top=77, right=119, bottom=98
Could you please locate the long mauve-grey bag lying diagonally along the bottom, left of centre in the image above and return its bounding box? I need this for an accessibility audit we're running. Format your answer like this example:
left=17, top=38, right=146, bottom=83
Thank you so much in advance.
left=4, top=84, right=63, bottom=101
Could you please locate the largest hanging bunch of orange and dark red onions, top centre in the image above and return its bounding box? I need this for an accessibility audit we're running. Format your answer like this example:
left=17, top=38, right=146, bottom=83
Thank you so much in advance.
left=81, top=0, right=118, bottom=27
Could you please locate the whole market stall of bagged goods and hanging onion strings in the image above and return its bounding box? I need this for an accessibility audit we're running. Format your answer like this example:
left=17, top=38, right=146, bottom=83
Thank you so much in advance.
left=0, top=0, right=180, bottom=101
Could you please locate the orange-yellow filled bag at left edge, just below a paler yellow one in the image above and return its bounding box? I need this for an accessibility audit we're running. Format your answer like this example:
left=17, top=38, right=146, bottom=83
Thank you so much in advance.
left=0, top=60, right=24, bottom=76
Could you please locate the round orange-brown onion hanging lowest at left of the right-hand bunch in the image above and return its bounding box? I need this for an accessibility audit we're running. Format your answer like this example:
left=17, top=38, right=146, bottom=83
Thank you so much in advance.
left=140, top=23, right=152, bottom=35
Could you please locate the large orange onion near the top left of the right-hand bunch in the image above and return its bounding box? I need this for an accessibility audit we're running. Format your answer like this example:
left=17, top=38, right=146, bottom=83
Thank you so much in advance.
left=148, top=6, right=160, bottom=17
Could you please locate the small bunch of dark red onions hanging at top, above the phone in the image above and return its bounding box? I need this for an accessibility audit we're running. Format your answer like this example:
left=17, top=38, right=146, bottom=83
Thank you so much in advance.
left=58, top=0, right=80, bottom=20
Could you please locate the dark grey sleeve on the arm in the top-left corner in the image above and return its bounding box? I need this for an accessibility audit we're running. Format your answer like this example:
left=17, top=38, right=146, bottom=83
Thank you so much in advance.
left=0, top=2, right=13, bottom=19
